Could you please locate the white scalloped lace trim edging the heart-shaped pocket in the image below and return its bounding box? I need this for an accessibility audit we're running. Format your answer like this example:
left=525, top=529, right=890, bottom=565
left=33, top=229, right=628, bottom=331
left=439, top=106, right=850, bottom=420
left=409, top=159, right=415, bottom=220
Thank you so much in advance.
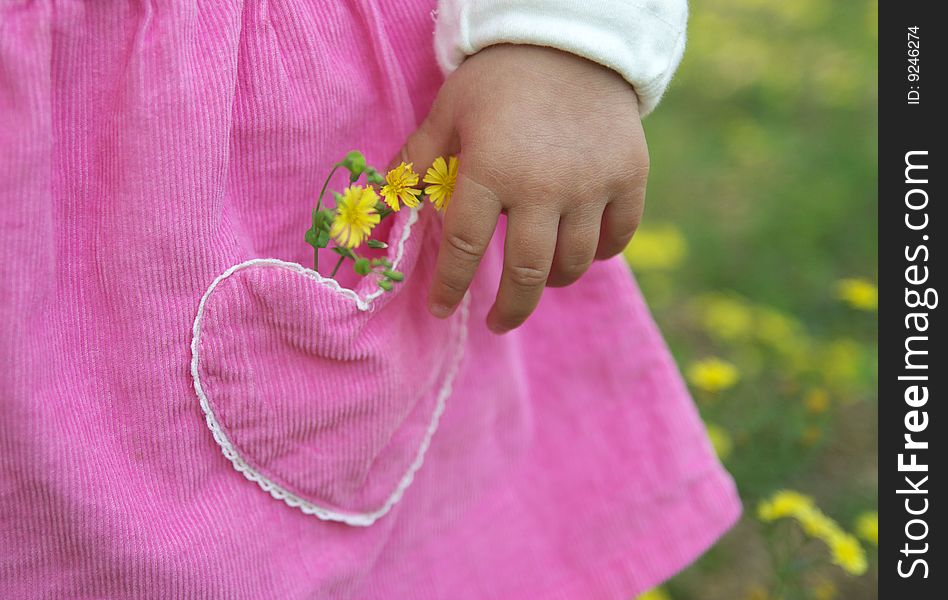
left=191, top=209, right=469, bottom=527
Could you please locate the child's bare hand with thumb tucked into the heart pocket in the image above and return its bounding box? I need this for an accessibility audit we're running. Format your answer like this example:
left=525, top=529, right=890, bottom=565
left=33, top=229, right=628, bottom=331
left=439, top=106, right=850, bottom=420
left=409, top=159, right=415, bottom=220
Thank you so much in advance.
left=404, top=45, right=649, bottom=333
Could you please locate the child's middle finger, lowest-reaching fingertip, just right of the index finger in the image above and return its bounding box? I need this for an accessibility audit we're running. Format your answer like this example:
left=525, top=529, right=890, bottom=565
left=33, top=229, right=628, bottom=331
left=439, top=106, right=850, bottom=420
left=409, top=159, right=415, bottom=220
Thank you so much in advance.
left=487, top=206, right=559, bottom=333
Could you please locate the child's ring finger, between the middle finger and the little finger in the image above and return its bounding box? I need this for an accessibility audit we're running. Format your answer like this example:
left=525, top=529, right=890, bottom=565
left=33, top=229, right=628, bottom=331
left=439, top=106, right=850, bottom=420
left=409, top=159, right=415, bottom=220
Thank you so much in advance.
left=546, top=206, right=602, bottom=287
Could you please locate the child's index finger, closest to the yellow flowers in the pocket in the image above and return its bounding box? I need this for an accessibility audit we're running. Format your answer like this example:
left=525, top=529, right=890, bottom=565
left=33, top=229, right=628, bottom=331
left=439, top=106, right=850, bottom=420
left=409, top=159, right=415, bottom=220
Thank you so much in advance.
left=428, top=172, right=502, bottom=318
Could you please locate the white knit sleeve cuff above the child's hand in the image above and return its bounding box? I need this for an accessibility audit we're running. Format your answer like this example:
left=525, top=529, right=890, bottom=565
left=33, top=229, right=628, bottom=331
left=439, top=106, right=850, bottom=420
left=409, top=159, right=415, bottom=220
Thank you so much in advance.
left=435, top=0, right=688, bottom=115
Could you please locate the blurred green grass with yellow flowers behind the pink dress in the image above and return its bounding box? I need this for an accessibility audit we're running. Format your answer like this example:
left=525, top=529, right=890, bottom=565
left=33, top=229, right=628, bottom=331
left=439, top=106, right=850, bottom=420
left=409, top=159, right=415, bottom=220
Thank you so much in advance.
left=626, top=0, right=878, bottom=600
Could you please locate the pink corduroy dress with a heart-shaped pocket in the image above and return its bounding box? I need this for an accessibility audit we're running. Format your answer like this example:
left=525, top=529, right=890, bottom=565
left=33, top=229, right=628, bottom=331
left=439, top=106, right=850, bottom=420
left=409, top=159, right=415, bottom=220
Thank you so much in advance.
left=0, top=0, right=739, bottom=600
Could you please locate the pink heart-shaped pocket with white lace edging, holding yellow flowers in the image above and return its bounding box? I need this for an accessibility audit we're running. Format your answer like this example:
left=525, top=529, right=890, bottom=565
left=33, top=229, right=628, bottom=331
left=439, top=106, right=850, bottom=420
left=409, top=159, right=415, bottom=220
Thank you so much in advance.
left=191, top=210, right=467, bottom=525
